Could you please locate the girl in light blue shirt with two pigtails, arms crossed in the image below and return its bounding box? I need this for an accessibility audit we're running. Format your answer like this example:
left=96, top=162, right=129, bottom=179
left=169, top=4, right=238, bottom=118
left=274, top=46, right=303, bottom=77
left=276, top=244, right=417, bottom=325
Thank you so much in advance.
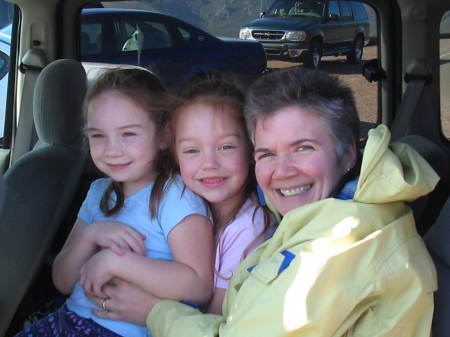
left=17, top=69, right=213, bottom=337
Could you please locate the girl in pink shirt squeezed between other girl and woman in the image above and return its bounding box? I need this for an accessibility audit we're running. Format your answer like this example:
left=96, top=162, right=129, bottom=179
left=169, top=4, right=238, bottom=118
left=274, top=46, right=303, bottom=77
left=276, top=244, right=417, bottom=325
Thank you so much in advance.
left=171, top=77, right=273, bottom=314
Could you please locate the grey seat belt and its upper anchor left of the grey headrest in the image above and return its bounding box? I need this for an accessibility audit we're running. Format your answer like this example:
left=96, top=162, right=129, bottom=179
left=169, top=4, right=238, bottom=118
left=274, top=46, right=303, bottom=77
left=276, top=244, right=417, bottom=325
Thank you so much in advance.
left=11, top=48, right=48, bottom=163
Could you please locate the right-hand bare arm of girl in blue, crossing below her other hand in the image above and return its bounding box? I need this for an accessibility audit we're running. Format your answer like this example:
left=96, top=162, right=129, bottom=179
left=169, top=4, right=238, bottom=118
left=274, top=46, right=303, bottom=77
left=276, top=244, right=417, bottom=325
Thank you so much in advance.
left=80, top=214, right=213, bottom=303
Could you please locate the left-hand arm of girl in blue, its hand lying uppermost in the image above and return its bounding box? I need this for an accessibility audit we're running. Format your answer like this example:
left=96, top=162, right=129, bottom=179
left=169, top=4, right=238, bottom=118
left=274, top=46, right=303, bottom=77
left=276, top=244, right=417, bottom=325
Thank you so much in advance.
left=53, top=219, right=145, bottom=294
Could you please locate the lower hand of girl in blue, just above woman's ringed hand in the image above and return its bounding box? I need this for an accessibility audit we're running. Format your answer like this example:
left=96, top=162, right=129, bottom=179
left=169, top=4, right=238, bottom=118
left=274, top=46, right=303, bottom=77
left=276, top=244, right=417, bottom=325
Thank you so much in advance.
left=80, top=249, right=119, bottom=298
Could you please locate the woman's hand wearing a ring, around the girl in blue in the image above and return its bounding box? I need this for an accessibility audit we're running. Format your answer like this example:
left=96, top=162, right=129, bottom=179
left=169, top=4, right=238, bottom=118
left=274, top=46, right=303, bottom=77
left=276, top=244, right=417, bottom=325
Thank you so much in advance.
left=90, top=279, right=160, bottom=325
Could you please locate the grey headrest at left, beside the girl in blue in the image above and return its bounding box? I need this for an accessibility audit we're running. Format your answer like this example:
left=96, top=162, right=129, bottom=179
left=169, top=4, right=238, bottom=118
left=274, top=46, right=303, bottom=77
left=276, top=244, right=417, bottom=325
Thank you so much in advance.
left=33, top=59, right=87, bottom=146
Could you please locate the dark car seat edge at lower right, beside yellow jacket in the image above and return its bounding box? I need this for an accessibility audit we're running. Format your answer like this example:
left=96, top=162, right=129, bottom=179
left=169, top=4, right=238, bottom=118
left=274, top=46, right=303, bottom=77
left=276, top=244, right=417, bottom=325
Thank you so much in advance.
left=424, top=198, right=450, bottom=337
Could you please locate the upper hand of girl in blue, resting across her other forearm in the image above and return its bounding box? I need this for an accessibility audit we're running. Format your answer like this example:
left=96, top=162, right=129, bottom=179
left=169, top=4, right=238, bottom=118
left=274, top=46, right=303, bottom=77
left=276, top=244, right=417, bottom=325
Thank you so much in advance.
left=86, top=221, right=146, bottom=255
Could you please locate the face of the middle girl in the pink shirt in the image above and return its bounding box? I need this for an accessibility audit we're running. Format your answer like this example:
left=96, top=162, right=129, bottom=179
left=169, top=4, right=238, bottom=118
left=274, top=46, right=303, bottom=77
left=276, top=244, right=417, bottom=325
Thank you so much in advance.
left=175, top=103, right=250, bottom=210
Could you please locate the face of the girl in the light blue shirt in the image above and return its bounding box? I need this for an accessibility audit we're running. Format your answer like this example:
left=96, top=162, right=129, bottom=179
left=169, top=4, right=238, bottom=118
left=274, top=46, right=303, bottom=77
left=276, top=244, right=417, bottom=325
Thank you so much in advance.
left=87, top=91, right=161, bottom=195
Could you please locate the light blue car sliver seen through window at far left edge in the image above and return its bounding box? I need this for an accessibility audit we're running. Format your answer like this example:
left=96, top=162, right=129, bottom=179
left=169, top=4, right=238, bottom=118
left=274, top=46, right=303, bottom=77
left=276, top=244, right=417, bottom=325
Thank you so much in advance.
left=0, top=25, right=12, bottom=138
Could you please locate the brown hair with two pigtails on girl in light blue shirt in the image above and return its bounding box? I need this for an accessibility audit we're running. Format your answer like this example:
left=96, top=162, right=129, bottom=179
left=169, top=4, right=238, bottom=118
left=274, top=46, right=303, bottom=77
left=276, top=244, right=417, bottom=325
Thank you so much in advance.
left=83, top=68, right=175, bottom=217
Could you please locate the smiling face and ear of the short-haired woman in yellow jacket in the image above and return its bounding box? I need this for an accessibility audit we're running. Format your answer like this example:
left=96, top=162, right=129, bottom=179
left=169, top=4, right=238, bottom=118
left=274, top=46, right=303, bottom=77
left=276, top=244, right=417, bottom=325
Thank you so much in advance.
left=255, top=107, right=355, bottom=215
